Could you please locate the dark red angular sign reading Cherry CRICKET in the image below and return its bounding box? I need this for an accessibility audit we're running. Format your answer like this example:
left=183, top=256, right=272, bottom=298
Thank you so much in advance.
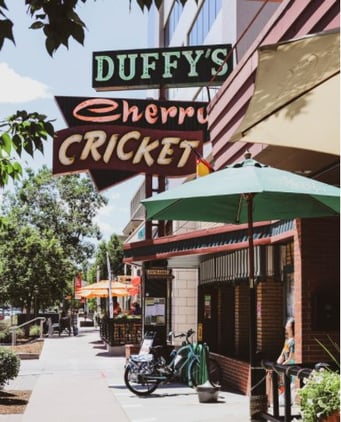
left=53, top=97, right=207, bottom=190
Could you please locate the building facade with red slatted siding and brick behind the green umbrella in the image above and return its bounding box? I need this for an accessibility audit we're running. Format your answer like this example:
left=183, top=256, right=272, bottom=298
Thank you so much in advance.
left=124, top=0, right=340, bottom=394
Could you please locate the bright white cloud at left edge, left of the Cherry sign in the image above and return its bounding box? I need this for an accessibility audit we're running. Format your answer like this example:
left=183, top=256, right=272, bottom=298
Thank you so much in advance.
left=0, top=63, right=52, bottom=104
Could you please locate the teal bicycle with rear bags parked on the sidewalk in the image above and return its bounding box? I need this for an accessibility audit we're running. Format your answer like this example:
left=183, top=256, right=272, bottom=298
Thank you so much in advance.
left=124, top=329, right=221, bottom=396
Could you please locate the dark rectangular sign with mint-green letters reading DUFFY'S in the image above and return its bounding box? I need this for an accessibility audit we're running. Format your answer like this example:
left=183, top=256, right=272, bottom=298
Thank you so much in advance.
left=92, top=44, right=233, bottom=91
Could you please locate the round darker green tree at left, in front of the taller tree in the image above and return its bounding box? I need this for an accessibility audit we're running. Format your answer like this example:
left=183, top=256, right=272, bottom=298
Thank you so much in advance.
left=0, top=224, right=75, bottom=313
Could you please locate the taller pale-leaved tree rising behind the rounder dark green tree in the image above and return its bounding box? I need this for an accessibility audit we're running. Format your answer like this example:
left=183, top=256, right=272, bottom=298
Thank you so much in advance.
left=2, top=166, right=108, bottom=265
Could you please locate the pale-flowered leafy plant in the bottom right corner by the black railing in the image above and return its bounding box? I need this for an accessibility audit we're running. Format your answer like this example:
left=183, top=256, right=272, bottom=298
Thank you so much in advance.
left=297, top=339, right=340, bottom=422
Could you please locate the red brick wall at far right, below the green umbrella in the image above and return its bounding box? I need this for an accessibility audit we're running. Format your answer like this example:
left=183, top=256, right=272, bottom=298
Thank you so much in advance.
left=295, top=218, right=340, bottom=362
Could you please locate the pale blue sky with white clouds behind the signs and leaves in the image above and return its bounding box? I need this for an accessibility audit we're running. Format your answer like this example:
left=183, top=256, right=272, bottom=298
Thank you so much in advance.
left=0, top=0, right=148, bottom=240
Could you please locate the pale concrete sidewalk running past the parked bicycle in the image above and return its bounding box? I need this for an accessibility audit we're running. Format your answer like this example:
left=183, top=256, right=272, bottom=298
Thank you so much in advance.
left=0, top=328, right=250, bottom=422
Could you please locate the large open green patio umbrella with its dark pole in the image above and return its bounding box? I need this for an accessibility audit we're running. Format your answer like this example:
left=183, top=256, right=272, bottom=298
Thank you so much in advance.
left=142, top=153, right=340, bottom=365
